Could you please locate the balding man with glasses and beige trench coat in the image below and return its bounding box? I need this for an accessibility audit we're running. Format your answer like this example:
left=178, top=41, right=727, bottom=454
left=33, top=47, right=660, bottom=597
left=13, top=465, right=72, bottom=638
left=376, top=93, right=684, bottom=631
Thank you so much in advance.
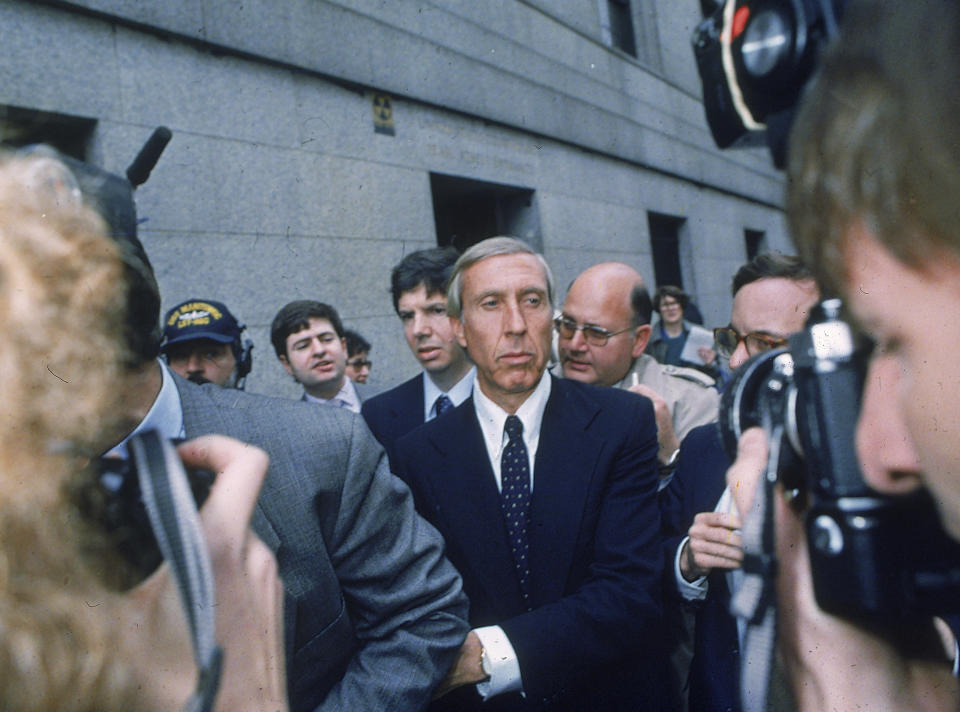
left=554, top=262, right=719, bottom=467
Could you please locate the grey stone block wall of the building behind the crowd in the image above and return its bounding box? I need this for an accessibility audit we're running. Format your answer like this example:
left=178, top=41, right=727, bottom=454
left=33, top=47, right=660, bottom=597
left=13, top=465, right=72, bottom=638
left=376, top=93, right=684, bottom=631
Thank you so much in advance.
left=0, top=0, right=788, bottom=396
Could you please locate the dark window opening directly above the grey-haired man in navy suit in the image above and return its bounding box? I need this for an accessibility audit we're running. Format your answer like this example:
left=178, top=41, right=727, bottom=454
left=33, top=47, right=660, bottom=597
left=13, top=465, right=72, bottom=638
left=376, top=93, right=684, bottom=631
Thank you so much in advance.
left=430, top=173, right=542, bottom=252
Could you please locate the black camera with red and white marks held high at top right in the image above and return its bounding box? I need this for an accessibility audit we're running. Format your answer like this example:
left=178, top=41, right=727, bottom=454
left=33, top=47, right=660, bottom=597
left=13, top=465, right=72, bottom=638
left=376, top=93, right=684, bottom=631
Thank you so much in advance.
left=692, top=0, right=846, bottom=168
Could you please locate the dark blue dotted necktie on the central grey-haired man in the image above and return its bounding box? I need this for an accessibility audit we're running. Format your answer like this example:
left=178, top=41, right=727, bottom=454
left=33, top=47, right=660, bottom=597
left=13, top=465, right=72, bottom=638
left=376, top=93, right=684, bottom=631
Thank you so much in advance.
left=500, top=415, right=532, bottom=610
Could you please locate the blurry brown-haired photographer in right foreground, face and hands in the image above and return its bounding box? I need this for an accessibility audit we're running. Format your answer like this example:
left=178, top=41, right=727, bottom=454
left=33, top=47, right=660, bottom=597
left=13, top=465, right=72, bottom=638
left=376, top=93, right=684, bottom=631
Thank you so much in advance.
left=727, top=0, right=960, bottom=710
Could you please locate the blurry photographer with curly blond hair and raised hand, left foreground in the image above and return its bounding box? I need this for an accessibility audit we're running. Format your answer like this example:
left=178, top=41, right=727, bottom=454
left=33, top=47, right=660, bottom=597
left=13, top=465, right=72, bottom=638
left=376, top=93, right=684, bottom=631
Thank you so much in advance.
left=0, top=157, right=286, bottom=712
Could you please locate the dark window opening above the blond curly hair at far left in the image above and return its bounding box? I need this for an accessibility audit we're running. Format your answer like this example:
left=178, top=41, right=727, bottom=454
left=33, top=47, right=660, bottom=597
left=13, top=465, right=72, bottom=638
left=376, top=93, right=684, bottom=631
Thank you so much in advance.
left=0, top=105, right=97, bottom=161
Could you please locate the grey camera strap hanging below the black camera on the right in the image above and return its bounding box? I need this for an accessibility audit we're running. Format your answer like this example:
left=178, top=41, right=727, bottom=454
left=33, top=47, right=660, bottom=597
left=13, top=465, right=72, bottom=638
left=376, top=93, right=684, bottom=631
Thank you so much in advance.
left=730, top=426, right=783, bottom=712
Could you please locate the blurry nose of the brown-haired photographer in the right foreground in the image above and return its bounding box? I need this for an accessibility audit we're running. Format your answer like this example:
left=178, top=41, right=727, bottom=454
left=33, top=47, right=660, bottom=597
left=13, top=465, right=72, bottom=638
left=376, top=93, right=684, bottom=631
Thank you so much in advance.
left=856, top=355, right=921, bottom=494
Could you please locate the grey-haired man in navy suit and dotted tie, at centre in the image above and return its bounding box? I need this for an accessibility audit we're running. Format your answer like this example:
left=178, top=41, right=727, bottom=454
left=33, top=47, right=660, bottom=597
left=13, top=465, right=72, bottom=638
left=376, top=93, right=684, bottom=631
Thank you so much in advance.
left=396, top=237, right=662, bottom=710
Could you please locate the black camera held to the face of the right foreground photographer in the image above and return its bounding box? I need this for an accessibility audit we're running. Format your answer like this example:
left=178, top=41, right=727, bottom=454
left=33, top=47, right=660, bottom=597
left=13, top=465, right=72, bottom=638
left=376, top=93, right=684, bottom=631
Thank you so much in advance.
left=720, top=299, right=960, bottom=619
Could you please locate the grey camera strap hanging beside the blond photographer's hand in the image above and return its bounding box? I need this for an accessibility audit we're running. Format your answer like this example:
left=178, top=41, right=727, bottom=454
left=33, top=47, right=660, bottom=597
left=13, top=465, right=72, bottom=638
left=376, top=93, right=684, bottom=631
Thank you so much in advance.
left=128, top=430, right=223, bottom=712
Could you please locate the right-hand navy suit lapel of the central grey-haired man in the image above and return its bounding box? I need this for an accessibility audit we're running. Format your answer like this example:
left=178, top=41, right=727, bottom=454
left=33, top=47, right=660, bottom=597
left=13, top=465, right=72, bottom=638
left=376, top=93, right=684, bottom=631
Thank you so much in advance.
left=529, top=379, right=603, bottom=601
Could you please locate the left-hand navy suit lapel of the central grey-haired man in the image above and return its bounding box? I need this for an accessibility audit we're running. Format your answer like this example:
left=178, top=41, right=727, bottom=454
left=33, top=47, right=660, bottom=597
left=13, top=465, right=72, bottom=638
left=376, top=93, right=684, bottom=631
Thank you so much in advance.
left=428, top=398, right=521, bottom=610
